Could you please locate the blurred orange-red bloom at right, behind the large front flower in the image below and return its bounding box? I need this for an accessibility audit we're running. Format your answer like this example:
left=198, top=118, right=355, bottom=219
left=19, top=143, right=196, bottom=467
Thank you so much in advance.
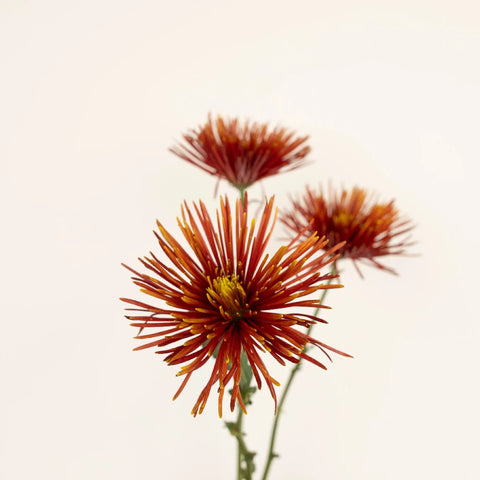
left=282, top=187, right=413, bottom=276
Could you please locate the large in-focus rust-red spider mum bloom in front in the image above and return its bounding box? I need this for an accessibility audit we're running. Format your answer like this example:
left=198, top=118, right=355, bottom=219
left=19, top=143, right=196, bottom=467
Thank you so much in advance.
left=122, top=197, right=345, bottom=416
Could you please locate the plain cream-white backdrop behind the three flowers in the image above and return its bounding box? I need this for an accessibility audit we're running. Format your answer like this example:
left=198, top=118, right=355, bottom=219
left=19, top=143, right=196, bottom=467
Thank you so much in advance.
left=0, top=0, right=480, bottom=480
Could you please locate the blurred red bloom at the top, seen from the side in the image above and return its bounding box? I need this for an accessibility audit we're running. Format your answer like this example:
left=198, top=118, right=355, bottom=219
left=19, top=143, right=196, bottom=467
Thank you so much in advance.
left=170, top=116, right=310, bottom=190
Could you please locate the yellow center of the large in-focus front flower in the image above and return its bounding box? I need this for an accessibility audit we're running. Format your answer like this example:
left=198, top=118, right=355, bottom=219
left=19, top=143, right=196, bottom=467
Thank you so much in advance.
left=207, top=275, right=248, bottom=320
